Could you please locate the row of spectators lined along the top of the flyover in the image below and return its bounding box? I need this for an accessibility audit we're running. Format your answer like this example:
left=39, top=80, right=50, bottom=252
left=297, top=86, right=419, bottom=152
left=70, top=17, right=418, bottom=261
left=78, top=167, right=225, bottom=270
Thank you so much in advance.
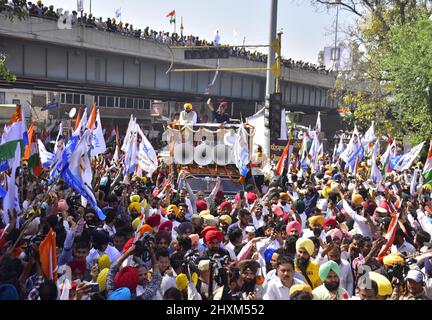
left=0, top=0, right=329, bottom=74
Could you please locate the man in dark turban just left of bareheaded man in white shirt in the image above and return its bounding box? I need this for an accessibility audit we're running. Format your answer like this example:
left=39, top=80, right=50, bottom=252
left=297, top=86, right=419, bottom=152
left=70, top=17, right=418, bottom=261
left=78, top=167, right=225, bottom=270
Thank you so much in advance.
left=239, top=260, right=264, bottom=300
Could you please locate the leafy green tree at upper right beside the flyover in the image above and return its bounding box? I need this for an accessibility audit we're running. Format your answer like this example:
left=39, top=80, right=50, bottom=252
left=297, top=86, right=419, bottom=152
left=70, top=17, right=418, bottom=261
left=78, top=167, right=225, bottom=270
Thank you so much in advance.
left=313, top=0, right=432, bottom=143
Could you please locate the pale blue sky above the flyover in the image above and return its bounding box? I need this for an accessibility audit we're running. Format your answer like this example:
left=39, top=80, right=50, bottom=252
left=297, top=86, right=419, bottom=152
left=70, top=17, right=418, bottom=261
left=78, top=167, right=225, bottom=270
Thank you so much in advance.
left=43, top=0, right=354, bottom=63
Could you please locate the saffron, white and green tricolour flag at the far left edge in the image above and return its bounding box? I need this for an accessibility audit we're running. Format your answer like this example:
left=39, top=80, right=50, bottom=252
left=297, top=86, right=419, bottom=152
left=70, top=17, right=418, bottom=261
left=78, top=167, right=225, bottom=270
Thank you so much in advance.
left=0, top=105, right=28, bottom=161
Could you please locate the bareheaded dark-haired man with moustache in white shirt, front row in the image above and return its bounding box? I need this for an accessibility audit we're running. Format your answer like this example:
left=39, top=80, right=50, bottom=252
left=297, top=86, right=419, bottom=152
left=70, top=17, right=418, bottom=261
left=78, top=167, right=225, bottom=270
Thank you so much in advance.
left=263, top=255, right=304, bottom=300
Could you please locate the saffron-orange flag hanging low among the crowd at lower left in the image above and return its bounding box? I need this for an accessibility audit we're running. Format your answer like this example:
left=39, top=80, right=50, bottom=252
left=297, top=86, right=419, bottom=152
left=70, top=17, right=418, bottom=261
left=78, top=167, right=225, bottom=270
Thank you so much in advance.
left=39, top=229, right=58, bottom=281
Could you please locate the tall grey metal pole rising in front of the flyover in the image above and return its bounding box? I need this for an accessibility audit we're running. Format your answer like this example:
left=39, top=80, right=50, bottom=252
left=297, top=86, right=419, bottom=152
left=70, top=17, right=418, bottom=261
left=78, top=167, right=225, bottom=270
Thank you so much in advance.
left=263, top=0, right=278, bottom=157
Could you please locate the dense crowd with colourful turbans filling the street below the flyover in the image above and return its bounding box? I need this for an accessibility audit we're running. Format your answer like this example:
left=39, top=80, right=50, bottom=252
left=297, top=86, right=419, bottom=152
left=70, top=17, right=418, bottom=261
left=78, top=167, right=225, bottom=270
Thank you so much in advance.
left=0, top=101, right=432, bottom=300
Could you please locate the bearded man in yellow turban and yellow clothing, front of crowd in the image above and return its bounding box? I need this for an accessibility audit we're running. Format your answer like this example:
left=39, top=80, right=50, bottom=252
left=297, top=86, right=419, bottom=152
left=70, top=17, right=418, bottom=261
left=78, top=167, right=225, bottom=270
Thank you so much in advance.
left=294, top=238, right=321, bottom=289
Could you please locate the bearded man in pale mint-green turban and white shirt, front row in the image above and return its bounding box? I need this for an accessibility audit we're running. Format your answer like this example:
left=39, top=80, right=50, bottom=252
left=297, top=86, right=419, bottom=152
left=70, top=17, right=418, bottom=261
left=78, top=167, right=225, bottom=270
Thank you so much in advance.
left=312, top=261, right=349, bottom=300
